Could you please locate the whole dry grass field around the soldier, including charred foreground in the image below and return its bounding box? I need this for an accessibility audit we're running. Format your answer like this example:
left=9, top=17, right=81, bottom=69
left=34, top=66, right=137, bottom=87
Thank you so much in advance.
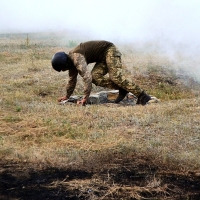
left=0, top=34, right=200, bottom=200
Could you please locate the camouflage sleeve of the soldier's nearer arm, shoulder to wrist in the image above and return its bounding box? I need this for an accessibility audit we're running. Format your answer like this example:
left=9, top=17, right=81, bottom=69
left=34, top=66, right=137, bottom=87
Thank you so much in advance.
left=70, top=53, right=92, bottom=98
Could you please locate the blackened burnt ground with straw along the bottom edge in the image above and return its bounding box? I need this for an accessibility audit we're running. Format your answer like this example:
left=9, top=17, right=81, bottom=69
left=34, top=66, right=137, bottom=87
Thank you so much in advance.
left=0, top=159, right=200, bottom=200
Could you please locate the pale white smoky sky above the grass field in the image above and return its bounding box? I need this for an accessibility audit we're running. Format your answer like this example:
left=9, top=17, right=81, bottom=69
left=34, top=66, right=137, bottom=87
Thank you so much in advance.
left=0, top=0, right=200, bottom=80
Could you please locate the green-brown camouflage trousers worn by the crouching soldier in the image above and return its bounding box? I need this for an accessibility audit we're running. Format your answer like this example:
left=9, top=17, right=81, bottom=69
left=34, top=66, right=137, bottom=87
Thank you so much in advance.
left=91, top=46, right=143, bottom=97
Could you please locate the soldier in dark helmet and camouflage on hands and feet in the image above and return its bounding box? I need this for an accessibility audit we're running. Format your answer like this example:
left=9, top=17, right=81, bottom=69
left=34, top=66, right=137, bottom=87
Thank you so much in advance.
left=51, top=41, right=151, bottom=105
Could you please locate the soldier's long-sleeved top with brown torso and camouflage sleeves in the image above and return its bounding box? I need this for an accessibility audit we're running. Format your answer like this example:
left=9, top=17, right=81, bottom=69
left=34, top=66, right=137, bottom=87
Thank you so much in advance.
left=67, top=40, right=113, bottom=98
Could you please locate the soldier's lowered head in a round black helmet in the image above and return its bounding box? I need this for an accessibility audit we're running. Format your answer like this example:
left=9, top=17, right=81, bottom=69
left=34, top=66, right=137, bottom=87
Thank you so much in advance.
left=51, top=52, right=70, bottom=72
